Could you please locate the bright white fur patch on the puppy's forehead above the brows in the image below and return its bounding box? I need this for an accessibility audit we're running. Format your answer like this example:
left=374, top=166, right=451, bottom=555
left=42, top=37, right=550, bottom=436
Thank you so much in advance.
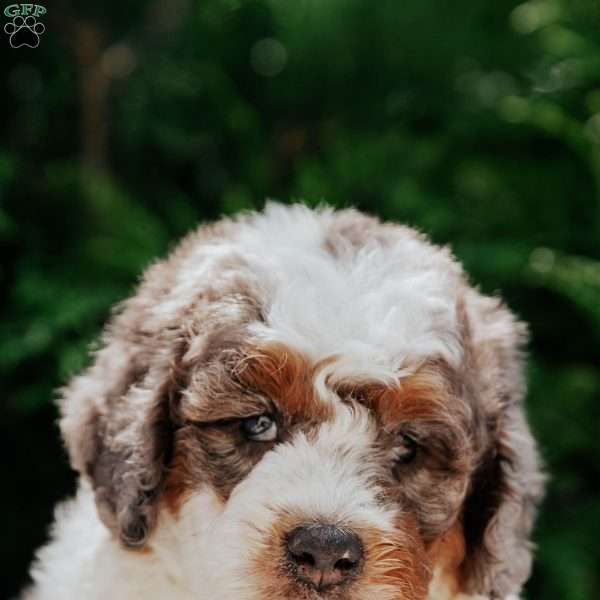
left=237, top=206, right=462, bottom=378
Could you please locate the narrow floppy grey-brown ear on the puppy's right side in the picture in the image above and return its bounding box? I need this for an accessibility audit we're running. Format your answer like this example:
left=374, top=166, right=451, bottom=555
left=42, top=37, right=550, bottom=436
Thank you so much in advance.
left=463, top=291, right=543, bottom=599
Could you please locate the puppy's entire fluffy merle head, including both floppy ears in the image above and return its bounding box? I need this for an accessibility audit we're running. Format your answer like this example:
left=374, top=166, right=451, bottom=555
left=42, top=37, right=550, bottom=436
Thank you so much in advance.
left=61, top=206, right=541, bottom=600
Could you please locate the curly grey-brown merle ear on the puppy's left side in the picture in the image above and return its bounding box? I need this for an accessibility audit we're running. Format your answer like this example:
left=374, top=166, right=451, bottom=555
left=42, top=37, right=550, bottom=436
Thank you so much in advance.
left=60, top=322, right=185, bottom=548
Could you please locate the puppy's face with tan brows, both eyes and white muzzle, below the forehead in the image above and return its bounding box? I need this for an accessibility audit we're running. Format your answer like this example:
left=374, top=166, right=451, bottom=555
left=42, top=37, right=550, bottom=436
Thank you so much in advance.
left=164, top=345, right=468, bottom=600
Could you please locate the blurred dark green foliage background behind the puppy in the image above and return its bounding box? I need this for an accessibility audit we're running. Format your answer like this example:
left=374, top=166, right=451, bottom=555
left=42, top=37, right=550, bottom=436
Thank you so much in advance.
left=0, top=0, right=600, bottom=600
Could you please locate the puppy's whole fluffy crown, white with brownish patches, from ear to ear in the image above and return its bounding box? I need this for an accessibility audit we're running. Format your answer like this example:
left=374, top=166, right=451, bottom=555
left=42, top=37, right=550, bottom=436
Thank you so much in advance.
left=165, top=205, right=466, bottom=380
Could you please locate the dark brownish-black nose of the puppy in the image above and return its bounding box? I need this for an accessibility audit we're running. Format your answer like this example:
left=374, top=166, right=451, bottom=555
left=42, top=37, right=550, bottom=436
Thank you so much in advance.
left=287, top=524, right=363, bottom=590
